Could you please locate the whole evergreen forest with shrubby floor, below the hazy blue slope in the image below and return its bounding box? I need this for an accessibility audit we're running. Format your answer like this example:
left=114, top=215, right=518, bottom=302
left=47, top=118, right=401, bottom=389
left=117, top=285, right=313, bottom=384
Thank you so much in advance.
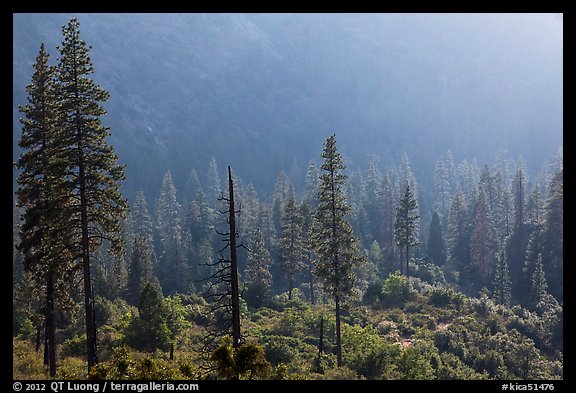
left=12, top=14, right=564, bottom=380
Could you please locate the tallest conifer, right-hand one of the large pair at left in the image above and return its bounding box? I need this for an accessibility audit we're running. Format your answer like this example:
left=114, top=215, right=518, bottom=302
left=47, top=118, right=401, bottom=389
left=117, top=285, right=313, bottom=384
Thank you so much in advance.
left=53, top=18, right=127, bottom=370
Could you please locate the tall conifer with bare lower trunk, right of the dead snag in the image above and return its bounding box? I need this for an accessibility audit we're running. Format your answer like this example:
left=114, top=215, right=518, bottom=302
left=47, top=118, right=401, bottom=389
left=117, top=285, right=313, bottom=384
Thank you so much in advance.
left=312, top=135, right=360, bottom=367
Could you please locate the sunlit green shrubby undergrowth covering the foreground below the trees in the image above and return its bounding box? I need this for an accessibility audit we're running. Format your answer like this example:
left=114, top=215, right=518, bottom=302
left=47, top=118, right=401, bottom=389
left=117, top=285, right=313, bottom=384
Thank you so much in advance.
left=13, top=274, right=563, bottom=380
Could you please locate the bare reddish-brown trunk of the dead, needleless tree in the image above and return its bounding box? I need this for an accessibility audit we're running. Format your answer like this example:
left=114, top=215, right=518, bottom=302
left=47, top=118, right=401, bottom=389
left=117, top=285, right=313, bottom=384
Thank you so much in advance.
left=228, top=166, right=241, bottom=348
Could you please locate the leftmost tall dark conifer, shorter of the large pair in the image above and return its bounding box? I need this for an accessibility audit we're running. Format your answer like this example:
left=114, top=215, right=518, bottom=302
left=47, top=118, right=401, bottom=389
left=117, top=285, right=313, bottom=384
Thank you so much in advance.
left=16, top=44, right=75, bottom=377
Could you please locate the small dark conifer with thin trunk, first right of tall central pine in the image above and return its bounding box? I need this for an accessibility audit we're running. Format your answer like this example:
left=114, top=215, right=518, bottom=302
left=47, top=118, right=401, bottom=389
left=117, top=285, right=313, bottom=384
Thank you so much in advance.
left=394, top=182, right=420, bottom=278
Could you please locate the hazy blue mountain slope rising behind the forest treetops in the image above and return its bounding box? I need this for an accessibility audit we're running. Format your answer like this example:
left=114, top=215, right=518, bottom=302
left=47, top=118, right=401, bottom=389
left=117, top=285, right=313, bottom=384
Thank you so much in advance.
left=13, top=14, right=563, bottom=201
